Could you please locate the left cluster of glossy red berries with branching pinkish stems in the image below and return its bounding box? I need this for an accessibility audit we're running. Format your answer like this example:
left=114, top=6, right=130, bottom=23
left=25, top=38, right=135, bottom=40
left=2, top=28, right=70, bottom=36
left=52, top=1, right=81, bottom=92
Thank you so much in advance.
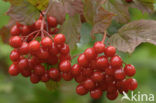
left=9, top=16, right=72, bottom=83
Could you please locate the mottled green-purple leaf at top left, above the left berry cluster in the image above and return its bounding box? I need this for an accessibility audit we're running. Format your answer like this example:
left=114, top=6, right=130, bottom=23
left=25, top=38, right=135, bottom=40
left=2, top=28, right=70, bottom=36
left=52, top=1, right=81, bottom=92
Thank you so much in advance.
left=7, top=0, right=40, bottom=25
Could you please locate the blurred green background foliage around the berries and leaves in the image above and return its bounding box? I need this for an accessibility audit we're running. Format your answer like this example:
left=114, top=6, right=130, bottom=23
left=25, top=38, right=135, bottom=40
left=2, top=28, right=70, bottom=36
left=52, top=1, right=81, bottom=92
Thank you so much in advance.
left=0, top=0, right=156, bottom=103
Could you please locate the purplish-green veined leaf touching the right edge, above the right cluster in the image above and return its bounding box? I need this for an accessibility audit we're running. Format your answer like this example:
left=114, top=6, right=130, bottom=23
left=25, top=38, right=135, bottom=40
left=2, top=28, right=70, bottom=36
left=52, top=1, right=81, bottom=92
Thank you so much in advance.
left=109, top=20, right=156, bottom=53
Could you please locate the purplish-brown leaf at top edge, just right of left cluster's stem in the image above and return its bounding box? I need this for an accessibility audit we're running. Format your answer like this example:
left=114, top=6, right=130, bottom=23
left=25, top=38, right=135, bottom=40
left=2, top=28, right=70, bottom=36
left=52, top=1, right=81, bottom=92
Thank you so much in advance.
left=48, top=0, right=83, bottom=24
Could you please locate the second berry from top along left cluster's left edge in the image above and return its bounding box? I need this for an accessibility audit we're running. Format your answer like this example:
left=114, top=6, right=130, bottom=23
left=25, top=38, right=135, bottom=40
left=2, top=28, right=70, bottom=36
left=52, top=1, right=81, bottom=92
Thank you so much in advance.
left=9, top=36, right=22, bottom=48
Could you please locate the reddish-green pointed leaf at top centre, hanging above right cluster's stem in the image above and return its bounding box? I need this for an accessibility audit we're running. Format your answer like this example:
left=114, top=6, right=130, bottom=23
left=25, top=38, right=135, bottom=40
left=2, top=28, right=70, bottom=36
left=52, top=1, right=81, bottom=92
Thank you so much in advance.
left=84, top=0, right=114, bottom=35
